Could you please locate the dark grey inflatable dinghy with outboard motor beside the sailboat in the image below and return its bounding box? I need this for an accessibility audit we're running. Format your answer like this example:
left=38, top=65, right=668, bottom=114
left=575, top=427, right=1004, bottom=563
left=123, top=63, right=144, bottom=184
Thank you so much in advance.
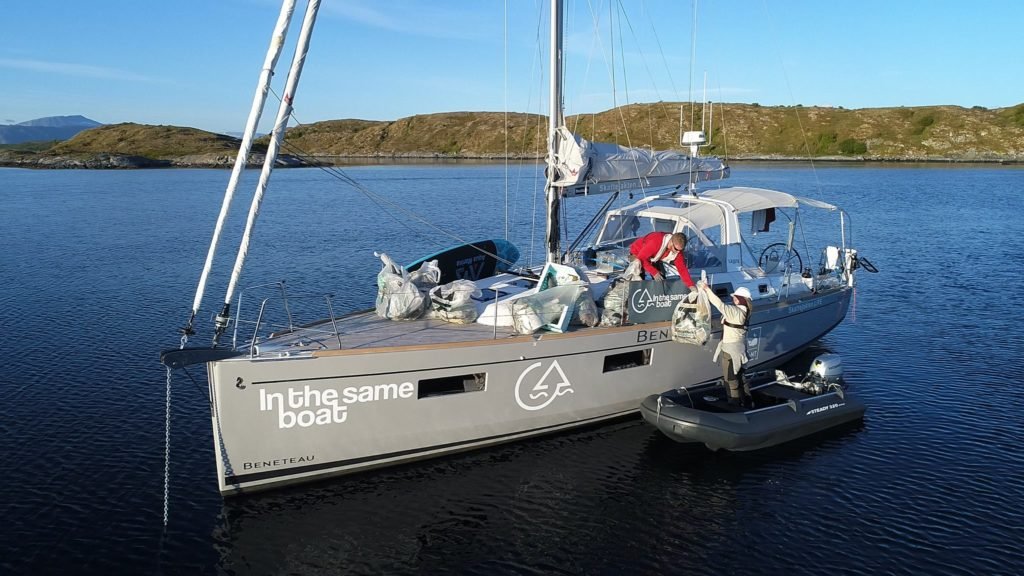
left=640, top=354, right=865, bottom=451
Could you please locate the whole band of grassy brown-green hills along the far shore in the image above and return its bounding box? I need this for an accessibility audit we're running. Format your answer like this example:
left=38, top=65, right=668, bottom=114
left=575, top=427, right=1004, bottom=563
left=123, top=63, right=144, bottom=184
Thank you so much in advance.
left=0, top=102, right=1024, bottom=168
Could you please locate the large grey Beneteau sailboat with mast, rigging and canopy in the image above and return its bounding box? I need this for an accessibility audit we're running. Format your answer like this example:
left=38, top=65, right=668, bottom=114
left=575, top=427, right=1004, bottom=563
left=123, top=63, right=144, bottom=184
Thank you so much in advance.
left=162, top=0, right=872, bottom=495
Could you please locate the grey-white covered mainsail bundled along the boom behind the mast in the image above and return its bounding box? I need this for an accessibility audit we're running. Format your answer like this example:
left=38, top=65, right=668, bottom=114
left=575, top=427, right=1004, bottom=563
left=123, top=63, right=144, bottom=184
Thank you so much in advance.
left=552, top=126, right=729, bottom=196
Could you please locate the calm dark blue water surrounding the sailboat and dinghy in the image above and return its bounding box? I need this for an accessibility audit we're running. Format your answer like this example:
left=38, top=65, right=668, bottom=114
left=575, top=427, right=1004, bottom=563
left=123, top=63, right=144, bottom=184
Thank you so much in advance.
left=0, top=165, right=1024, bottom=574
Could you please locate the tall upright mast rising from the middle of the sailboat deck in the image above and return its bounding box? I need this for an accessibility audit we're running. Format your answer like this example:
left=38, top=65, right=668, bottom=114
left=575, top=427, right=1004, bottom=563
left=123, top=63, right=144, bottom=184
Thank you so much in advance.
left=544, top=0, right=564, bottom=262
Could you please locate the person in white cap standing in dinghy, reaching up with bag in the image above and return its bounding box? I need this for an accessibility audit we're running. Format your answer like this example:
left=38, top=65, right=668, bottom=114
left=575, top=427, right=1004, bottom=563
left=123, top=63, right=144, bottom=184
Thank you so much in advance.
left=700, top=282, right=754, bottom=408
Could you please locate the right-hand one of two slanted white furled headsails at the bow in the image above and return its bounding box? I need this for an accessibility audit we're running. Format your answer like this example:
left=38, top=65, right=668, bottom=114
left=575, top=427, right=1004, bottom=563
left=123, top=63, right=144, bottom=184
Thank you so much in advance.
left=213, top=0, right=321, bottom=345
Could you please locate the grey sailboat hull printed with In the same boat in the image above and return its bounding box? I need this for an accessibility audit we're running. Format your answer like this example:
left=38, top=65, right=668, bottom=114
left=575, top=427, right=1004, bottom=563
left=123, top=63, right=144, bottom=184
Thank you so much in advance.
left=208, top=287, right=852, bottom=494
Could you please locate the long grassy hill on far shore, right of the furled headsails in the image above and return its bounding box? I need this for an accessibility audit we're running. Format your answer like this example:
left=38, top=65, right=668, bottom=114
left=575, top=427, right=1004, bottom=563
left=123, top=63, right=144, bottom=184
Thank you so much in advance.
left=243, top=102, right=1024, bottom=161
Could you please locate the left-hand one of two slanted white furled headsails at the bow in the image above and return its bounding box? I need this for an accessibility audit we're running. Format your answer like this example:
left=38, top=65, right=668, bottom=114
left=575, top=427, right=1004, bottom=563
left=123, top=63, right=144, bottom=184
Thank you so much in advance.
left=180, top=0, right=295, bottom=340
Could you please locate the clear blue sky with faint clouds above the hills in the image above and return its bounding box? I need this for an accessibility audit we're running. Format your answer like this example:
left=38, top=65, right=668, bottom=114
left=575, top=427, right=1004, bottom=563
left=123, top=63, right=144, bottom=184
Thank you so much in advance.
left=0, top=0, right=1024, bottom=131
